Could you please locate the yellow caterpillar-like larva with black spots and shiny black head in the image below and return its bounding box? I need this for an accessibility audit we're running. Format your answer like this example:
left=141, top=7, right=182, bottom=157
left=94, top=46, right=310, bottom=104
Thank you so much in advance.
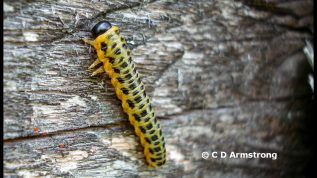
left=84, top=21, right=166, bottom=167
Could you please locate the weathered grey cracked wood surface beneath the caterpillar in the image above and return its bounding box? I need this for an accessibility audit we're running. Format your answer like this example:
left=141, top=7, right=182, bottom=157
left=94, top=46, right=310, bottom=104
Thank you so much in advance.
left=4, top=0, right=313, bottom=178
